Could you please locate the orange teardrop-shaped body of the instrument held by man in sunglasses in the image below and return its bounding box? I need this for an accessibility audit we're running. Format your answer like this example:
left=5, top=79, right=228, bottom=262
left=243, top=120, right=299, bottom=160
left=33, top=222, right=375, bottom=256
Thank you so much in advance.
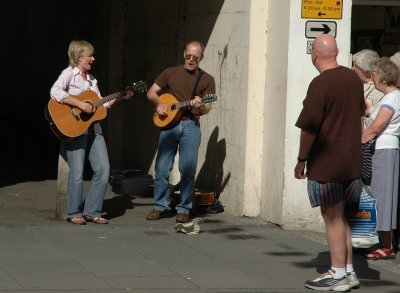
left=153, top=94, right=185, bottom=127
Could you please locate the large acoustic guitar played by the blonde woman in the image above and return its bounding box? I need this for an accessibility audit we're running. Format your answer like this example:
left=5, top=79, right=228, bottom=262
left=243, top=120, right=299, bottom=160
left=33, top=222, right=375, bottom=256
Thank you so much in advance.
left=44, top=81, right=147, bottom=141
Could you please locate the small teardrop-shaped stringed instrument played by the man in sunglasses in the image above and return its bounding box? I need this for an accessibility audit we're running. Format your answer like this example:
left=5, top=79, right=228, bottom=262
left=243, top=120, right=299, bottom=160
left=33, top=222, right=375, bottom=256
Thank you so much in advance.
left=153, top=94, right=217, bottom=128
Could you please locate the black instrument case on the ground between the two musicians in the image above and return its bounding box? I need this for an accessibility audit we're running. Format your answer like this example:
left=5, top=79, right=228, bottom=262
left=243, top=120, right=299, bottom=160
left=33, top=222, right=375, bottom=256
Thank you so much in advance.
left=109, top=169, right=154, bottom=196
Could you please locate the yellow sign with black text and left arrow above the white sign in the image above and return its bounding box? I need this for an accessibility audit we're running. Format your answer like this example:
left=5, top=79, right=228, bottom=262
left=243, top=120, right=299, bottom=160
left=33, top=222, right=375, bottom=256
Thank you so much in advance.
left=301, top=0, right=344, bottom=19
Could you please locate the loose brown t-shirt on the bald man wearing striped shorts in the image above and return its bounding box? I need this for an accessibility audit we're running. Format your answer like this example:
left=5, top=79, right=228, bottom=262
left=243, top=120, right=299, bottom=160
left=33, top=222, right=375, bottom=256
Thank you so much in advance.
left=296, top=66, right=366, bottom=182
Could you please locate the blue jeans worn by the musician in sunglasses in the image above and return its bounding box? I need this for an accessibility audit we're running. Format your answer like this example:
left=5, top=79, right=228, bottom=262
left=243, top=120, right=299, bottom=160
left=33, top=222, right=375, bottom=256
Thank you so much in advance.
left=154, top=120, right=201, bottom=214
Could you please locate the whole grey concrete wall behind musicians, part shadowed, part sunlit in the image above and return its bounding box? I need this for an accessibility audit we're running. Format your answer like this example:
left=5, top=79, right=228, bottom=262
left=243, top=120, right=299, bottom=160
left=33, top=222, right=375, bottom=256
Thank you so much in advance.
left=107, top=0, right=250, bottom=215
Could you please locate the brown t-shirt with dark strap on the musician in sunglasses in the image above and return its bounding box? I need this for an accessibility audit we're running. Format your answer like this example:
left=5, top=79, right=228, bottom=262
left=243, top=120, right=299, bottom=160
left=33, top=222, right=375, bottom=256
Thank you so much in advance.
left=154, top=65, right=215, bottom=102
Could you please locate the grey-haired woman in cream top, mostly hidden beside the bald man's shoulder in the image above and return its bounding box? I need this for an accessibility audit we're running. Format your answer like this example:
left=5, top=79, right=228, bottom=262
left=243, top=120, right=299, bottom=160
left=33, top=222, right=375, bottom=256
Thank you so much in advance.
left=353, top=49, right=383, bottom=117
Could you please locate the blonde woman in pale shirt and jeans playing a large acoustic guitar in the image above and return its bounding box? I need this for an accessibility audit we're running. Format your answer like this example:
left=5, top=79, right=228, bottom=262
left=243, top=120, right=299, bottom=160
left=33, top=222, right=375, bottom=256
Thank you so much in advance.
left=50, top=40, right=133, bottom=225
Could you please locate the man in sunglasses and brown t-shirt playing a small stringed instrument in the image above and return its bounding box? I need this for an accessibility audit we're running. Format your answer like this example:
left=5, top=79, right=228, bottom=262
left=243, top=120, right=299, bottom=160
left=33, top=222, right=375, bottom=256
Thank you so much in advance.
left=146, top=41, right=215, bottom=223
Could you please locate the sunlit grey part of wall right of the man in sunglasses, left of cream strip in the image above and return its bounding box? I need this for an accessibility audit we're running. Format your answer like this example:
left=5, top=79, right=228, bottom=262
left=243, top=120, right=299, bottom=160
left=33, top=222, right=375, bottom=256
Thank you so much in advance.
left=197, top=0, right=251, bottom=216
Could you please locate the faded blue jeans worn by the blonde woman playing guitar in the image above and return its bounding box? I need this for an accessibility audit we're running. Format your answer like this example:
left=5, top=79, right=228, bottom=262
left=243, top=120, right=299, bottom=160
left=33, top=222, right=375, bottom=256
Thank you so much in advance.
left=65, top=134, right=110, bottom=218
